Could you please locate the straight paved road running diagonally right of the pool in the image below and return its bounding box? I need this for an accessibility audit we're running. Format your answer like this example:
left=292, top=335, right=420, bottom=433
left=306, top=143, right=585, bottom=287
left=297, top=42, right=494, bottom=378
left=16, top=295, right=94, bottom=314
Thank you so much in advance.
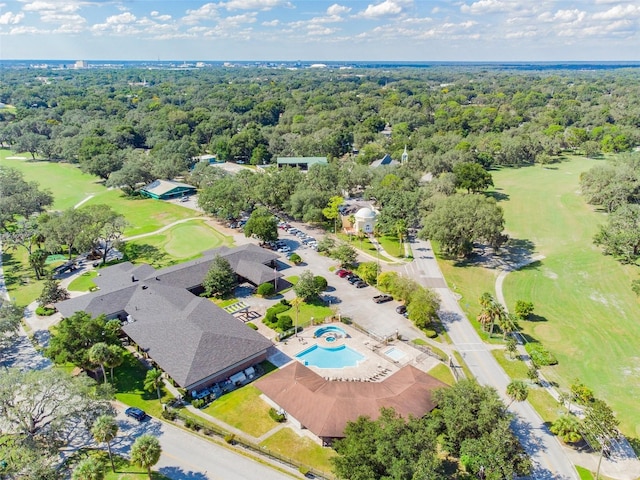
left=406, top=236, right=578, bottom=480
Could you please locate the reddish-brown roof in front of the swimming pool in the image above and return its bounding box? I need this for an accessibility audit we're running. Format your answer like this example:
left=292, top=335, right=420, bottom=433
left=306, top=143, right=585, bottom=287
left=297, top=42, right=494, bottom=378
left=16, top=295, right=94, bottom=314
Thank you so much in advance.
left=255, top=362, right=447, bottom=438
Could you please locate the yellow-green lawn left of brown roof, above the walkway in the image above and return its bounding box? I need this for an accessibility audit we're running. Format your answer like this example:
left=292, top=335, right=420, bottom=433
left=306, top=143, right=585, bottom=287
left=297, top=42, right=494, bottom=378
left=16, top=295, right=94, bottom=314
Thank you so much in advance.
left=203, top=385, right=278, bottom=437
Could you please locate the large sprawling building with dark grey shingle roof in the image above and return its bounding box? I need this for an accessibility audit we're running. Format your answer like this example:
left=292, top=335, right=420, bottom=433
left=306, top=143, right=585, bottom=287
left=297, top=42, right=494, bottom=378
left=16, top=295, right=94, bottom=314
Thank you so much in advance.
left=56, top=244, right=282, bottom=391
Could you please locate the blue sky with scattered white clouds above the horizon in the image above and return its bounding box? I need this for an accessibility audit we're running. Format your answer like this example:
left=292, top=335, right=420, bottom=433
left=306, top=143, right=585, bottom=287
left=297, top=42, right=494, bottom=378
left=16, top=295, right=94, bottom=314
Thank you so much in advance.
left=0, top=0, right=640, bottom=61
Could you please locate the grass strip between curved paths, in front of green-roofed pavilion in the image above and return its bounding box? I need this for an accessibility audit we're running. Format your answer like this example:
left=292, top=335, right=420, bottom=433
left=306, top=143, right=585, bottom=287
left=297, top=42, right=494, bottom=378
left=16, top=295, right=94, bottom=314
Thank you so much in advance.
left=84, top=190, right=196, bottom=238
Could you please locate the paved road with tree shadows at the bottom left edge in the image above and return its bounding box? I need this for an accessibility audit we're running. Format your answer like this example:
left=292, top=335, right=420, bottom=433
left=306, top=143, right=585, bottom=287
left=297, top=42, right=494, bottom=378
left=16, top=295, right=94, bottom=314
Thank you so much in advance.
left=113, top=407, right=300, bottom=480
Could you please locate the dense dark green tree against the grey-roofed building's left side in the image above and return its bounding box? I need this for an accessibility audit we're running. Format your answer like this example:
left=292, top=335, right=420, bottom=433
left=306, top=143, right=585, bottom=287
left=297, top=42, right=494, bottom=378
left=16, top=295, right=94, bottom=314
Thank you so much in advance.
left=45, top=312, right=120, bottom=369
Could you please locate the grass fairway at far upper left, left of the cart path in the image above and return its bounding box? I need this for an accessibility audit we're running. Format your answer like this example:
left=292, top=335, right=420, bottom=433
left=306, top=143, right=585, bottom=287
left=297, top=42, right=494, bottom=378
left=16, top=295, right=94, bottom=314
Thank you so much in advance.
left=0, top=154, right=107, bottom=210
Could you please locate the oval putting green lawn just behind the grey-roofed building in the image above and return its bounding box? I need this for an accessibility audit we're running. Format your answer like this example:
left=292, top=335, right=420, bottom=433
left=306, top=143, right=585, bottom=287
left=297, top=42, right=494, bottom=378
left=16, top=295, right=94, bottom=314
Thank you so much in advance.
left=126, top=220, right=233, bottom=267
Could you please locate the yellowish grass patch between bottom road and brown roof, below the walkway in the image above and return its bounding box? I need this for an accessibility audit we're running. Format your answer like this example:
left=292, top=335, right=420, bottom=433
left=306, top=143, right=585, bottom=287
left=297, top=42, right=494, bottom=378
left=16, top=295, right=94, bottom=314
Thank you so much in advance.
left=260, top=428, right=337, bottom=473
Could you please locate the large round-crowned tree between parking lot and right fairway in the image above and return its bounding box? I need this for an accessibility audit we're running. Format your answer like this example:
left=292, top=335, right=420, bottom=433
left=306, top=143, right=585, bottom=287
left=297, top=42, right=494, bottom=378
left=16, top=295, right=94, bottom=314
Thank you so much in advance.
left=420, top=194, right=505, bottom=256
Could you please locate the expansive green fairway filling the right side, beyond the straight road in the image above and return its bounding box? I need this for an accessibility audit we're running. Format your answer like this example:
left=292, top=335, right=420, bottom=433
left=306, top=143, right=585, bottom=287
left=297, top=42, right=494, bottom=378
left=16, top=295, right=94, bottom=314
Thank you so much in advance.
left=450, top=157, right=640, bottom=437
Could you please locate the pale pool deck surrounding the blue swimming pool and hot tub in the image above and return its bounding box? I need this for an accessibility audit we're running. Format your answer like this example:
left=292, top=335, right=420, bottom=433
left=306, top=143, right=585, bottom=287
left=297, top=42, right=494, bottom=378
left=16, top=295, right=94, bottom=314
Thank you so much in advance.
left=276, top=323, right=438, bottom=382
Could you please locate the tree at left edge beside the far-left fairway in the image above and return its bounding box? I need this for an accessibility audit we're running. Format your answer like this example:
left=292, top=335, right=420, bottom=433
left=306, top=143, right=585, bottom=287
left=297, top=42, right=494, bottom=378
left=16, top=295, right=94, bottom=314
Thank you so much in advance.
left=0, top=165, right=53, bottom=231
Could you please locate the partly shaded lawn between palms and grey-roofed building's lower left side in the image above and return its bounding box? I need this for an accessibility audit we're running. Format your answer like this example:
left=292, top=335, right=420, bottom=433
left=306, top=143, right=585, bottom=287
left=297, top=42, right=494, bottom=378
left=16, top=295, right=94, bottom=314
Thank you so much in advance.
left=112, top=352, right=173, bottom=417
